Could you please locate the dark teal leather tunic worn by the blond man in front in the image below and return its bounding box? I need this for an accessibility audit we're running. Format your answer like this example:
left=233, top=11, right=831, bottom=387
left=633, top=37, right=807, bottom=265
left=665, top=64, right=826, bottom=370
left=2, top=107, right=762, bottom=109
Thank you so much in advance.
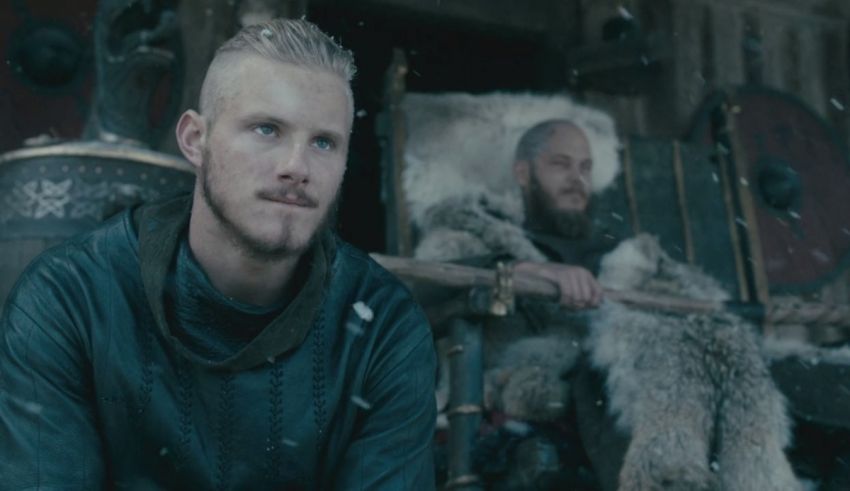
left=0, top=198, right=436, bottom=490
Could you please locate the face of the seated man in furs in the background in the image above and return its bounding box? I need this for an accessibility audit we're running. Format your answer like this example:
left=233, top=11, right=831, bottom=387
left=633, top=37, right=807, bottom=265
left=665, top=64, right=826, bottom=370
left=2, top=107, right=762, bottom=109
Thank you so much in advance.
left=527, top=125, right=593, bottom=212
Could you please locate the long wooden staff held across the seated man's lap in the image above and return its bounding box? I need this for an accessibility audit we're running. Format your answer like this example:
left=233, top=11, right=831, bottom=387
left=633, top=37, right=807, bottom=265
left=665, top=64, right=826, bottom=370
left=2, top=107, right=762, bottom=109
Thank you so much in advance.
left=371, top=254, right=850, bottom=327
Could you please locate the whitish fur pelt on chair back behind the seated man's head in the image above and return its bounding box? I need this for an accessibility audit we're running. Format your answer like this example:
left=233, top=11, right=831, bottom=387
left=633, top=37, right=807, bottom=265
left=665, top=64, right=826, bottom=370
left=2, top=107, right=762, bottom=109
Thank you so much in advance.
left=402, top=93, right=620, bottom=226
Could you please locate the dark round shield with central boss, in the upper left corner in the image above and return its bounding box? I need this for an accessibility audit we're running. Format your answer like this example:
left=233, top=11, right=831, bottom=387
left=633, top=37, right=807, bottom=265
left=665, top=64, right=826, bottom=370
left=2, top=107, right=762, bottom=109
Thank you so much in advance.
left=0, top=0, right=98, bottom=152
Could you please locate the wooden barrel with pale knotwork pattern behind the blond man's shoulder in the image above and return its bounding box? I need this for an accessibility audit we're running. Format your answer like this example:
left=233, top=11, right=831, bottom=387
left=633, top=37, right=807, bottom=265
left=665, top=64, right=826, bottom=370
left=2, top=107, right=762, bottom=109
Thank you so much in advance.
left=0, top=142, right=195, bottom=305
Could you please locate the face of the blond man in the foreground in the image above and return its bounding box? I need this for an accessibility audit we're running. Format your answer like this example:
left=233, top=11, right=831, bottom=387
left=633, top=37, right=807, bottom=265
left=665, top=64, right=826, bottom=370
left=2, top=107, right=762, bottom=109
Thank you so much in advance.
left=196, top=56, right=352, bottom=258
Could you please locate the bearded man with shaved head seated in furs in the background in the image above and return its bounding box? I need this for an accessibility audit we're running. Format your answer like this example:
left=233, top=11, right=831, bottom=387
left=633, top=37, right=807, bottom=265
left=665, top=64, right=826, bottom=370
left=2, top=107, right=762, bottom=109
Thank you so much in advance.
left=417, top=120, right=799, bottom=491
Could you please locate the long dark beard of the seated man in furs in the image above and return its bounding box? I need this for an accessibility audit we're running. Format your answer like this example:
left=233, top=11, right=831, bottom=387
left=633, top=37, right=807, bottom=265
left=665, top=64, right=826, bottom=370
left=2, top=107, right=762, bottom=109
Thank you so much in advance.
left=524, top=172, right=591, bottom=239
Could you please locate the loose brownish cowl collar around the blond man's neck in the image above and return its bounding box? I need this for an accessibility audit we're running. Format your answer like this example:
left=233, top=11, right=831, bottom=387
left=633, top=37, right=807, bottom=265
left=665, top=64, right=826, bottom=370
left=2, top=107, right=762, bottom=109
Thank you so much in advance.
left=134, top=194, right=336, bottom=371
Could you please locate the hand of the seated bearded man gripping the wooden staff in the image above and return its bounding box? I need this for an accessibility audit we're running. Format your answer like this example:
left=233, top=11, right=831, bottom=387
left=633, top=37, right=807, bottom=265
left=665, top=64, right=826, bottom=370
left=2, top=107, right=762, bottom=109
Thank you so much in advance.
left=514, top=261, right=602, bottom=309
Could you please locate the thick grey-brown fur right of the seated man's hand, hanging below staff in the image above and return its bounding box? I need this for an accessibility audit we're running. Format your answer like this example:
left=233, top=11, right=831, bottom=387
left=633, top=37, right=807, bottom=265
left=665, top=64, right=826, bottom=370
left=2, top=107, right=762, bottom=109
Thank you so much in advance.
left=586, top=235, right=801, bottom=491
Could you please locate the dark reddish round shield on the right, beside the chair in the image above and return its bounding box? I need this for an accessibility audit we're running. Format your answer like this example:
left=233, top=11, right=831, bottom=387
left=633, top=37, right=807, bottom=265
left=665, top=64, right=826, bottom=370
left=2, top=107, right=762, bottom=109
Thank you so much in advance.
left=692, top=87, right=850, bottom=293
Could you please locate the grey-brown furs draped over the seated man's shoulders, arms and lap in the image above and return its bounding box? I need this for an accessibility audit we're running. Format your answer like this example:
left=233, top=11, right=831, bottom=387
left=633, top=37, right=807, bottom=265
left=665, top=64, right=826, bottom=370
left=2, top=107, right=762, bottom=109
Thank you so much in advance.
left=417, top=195, right=799, bottom=491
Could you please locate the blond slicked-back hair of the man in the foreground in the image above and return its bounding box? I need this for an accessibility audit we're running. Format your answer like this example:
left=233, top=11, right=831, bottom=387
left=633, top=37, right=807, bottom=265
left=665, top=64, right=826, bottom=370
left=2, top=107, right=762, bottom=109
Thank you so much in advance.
left=199, top=19, right=357, bottom=120
